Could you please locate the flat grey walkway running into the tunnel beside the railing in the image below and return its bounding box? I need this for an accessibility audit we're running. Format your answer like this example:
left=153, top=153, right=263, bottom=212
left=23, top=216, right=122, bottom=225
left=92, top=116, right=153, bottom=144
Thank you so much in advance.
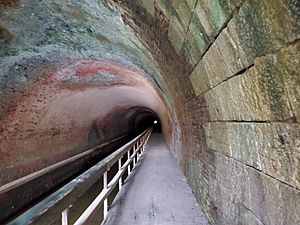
left=104, top=134, right=207, bottom=225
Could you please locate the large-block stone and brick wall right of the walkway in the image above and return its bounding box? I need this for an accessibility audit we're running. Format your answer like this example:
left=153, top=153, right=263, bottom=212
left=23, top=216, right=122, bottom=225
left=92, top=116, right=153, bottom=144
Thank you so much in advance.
left=114, top=0, right=300, bottom=225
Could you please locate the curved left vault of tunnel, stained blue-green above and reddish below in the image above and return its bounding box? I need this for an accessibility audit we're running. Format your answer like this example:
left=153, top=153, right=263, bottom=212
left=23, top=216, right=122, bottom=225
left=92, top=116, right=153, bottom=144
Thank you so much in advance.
left=0, top=1, right=171, bottom=184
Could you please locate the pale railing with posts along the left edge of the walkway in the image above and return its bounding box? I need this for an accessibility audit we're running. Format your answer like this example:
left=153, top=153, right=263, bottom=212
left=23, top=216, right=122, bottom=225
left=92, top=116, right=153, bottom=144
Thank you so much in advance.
left=8, top=129, right=152, bottom=225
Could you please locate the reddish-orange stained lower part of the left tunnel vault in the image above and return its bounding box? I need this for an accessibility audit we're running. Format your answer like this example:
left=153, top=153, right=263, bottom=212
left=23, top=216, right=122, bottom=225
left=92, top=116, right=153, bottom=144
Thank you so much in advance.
left=0, top=60, right=170, bottom=186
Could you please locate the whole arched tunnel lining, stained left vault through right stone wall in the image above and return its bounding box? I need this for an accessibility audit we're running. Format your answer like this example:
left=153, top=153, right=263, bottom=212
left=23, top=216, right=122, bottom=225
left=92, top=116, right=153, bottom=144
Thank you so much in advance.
left=0, top=0, right=300, bottom=225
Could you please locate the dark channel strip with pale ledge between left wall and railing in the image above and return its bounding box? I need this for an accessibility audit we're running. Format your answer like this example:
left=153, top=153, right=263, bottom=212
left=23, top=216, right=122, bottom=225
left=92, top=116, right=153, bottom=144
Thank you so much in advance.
left=0, top=133, right=130, bottom=224
